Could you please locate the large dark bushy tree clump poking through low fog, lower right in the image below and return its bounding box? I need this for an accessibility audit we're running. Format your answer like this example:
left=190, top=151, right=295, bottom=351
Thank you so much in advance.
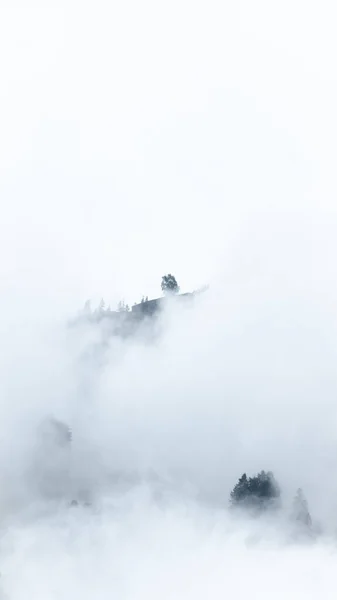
left=230, top=471, right=280, bottom=510
